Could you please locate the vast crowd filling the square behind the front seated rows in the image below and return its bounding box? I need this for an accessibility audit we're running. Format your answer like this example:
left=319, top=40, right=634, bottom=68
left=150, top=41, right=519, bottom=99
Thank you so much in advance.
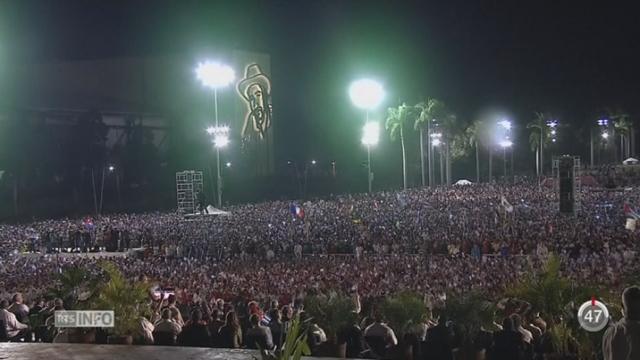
left=0, top=181, right=640, bottom=358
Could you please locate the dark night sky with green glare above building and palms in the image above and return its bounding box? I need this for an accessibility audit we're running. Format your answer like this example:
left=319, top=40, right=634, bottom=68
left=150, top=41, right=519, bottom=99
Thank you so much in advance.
left=0, top=0, right=640, bottom=191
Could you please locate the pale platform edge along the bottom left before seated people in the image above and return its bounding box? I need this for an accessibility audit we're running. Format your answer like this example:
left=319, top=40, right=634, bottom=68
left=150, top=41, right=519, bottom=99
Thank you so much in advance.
left=0, top=343, right=352, bottom=360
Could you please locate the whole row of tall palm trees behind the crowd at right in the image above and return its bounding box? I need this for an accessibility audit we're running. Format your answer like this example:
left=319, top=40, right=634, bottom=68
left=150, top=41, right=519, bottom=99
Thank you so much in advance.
left=385, top=98, right=635, bottom=189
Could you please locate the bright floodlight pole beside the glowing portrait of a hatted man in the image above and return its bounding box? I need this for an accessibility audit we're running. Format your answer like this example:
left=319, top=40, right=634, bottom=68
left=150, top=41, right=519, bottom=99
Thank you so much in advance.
left=196, top=61, right=235, bottom=208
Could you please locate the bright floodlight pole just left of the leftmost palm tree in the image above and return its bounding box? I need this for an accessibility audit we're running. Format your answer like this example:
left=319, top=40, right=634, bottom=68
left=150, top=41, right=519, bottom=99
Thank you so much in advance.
left=349, top=79, right=384, bottom=193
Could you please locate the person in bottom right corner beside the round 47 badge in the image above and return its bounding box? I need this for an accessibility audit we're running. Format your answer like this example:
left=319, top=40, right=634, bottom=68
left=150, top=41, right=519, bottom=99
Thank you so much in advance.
left=602, top=286, right=640, bottom=360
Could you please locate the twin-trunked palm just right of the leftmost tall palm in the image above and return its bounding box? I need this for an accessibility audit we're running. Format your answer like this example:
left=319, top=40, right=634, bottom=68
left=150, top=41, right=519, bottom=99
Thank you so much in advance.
left=414, top=98, right=447, bottom=186
